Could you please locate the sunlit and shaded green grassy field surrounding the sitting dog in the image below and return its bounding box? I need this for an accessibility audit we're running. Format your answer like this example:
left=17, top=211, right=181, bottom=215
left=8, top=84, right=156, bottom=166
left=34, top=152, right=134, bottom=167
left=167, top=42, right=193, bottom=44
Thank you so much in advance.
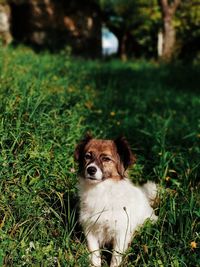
left=0, top=47, right=200, bottom=267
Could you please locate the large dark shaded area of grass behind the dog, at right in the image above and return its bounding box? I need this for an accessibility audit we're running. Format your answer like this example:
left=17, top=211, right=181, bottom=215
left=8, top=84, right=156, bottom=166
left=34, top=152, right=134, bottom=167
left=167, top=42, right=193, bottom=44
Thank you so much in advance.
left=84, top=61, right=200, bottom=185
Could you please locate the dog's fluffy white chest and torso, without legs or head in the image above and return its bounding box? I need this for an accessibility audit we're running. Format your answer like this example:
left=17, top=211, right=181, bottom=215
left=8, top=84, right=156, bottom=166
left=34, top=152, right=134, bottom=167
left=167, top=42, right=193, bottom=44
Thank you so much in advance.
left=80, top=180, right=152, bottom=245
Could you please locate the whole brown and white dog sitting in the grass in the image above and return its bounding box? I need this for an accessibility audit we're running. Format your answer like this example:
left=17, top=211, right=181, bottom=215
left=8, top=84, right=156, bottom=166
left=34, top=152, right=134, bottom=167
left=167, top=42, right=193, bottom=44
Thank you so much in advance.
left=74, top=135, right=157, bottom=267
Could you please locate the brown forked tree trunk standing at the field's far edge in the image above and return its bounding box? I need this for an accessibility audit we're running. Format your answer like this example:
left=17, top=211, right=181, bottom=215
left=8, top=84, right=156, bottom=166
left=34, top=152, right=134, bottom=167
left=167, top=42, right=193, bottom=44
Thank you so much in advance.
left=159, top=0, right=181, bottom=62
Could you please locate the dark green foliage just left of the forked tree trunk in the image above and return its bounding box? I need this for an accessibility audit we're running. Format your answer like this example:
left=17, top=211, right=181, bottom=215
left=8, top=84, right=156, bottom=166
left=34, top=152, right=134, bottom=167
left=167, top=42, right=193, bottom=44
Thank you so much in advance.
left=100, top=0, right=161, bottom=60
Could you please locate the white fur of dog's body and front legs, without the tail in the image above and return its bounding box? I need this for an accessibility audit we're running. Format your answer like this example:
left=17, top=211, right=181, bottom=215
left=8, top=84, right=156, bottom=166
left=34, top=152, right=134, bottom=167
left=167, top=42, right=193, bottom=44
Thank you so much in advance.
left=80, top=178, right=157, bottom=267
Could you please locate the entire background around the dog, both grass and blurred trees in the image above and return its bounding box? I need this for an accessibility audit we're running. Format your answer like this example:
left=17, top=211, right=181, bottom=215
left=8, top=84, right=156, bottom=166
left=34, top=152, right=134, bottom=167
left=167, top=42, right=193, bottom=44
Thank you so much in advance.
left=0, top=0, right=200, bottom=267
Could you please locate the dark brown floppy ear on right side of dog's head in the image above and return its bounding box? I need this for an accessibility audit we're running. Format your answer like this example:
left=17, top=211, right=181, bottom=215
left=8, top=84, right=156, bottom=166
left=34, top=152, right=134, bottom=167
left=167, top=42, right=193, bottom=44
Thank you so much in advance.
left=114, top=136, right=136, bottom=170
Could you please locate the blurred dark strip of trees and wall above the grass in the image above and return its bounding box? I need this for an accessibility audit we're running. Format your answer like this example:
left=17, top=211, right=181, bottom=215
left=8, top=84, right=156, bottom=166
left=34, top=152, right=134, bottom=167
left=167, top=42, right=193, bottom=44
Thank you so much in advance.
left=0, top=0, right=200, bottom=62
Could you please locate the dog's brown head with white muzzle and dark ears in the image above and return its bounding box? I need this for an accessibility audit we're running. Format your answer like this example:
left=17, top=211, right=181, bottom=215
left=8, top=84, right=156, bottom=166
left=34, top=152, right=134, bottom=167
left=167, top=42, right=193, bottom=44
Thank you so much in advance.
left=74, top=135, right=135, bottom=183
